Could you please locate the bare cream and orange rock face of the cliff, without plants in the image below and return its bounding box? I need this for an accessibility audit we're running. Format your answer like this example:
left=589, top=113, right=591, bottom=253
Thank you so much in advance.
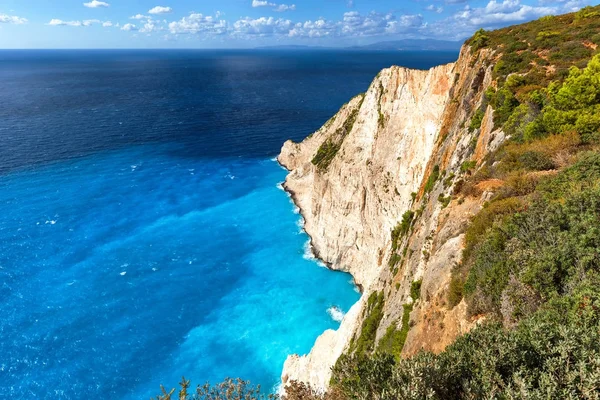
left=278, top=48, right=504, bottom=390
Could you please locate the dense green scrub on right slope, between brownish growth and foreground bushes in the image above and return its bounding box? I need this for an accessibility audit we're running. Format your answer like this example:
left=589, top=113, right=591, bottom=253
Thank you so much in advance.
left=465, top=153, right=600, bottom=322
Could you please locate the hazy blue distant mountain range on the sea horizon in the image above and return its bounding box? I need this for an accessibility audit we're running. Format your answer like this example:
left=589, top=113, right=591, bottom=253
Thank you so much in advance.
left=257, top=39, right=463, bottom=51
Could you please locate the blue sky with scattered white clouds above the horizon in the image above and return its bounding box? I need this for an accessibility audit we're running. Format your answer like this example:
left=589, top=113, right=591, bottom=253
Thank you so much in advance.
left=0, top=0, right=593, bottom=48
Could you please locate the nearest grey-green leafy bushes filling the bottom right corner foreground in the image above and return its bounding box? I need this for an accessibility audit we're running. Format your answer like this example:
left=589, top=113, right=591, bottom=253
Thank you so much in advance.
left=332, top=278, right=600, bottom=400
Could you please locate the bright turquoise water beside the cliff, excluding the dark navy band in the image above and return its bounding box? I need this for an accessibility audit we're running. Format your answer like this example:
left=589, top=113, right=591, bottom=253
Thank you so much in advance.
left=0, top=146, right=358, bottom=398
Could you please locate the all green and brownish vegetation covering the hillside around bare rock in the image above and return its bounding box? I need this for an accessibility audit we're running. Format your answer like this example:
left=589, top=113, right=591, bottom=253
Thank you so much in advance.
left=160, top=6, right=600, bottom=400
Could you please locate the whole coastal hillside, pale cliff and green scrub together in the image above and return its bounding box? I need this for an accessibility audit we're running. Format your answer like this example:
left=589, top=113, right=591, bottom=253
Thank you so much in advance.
left=156, top=6, right=600, bottom=400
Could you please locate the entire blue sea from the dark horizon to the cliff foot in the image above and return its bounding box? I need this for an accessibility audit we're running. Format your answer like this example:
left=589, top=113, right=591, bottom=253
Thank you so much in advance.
left=0, top=50, right=457, bottom=399
